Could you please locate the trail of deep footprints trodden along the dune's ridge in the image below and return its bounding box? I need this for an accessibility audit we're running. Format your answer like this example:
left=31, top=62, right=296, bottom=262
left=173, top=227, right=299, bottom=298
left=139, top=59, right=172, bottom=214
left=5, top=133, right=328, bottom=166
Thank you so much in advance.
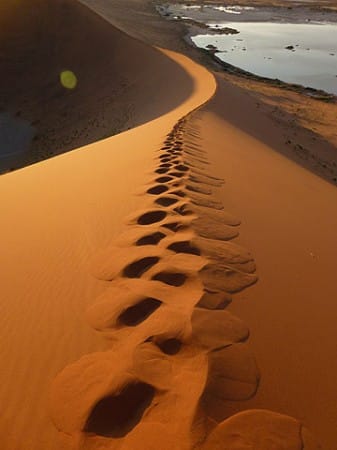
left=51, top=110, right=318, bottom=450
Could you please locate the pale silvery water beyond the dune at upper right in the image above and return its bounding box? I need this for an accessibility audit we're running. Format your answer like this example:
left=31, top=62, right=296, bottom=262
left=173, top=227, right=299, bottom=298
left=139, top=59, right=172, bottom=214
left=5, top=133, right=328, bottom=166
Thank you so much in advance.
left=192, top=22, right=337, bottom=94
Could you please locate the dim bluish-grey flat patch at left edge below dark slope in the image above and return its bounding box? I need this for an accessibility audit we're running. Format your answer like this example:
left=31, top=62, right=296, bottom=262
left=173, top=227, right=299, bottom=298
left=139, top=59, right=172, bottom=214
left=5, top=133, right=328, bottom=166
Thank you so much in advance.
left=0, top=112, right=35, bottom=171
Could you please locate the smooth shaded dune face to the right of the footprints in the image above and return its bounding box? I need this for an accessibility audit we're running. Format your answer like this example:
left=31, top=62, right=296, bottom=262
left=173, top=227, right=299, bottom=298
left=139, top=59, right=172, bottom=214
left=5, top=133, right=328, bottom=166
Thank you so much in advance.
left=194, top=75, right=337, bottom=450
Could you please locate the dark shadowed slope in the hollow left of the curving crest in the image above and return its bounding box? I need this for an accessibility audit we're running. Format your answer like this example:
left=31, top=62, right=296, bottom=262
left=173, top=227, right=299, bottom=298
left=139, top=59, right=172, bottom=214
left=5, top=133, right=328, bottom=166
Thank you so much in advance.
left=0, top=0, right=193, bottom=172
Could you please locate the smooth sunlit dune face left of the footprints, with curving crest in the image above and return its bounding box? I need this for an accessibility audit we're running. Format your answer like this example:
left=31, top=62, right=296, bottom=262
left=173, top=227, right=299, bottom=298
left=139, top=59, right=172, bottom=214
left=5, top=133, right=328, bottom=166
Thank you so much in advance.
left=0, top=13, right=215, bottom=450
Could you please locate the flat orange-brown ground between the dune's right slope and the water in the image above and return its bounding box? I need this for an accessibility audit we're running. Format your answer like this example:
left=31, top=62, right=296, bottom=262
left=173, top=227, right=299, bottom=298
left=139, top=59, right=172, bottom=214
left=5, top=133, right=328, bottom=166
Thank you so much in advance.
left=213, top=72, right=337, bottom=185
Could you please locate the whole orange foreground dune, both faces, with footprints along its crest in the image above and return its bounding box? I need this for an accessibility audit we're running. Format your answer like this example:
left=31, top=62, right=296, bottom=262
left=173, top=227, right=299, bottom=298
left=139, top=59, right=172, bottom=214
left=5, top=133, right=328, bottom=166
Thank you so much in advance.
left=0, top=0, right=337, bottom=450
